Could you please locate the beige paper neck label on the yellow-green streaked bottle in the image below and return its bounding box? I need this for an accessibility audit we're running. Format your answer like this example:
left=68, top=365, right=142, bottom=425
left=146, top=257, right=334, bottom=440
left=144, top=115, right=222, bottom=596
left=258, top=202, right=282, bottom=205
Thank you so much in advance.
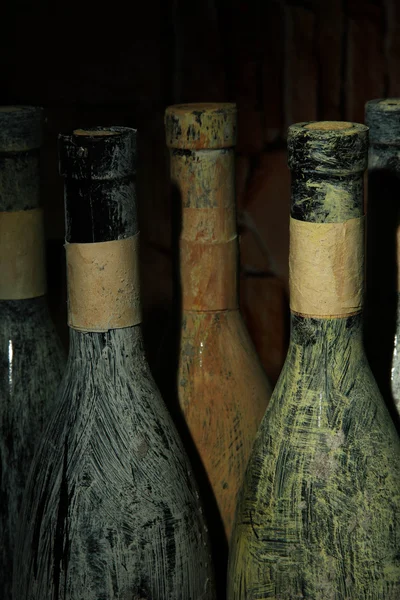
left=289, top=217, right=364, bottom=318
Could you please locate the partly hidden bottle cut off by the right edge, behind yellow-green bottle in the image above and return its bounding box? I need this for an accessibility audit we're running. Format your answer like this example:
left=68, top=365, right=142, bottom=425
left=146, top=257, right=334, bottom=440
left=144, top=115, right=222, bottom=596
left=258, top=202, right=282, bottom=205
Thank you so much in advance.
left=365, top=98, right=400, bottom=422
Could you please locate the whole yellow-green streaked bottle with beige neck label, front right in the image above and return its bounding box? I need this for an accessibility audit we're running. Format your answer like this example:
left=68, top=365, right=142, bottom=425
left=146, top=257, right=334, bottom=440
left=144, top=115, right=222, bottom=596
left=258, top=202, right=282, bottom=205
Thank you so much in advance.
left=228, top=122, right=400, bottom=600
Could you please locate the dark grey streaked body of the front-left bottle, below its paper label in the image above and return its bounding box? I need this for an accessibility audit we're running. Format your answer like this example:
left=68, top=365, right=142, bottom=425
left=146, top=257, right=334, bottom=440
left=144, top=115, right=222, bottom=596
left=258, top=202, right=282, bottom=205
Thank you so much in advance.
left=15, top=330, right=213, bottom=600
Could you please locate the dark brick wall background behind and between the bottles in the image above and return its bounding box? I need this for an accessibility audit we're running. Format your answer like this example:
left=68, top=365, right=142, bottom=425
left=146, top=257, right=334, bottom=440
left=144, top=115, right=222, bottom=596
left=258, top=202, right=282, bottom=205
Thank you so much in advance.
left=0, top=0, right=400, bottom=381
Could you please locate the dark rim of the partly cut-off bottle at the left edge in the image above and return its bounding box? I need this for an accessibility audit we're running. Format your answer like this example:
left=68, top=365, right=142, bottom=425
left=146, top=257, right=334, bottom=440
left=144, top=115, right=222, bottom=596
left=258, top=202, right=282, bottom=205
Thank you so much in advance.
left=0, top=106, right=43, bottom=153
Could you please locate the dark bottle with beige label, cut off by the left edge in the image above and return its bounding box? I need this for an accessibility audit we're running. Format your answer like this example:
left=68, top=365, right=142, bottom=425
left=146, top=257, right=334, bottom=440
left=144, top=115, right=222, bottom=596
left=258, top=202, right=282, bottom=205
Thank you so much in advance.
left=0, top=106, right=65, bottom=600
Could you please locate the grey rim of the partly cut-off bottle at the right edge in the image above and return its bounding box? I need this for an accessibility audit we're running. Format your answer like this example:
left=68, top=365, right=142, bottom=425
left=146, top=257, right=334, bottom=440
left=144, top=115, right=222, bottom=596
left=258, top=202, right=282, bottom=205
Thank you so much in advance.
left=365, top=98, right=400, bottom=146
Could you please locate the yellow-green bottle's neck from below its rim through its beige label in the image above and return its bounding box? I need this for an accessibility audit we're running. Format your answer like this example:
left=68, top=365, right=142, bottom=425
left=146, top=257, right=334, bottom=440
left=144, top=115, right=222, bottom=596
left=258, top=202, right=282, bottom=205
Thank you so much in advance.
left=289, top=172, right=364, bottom=319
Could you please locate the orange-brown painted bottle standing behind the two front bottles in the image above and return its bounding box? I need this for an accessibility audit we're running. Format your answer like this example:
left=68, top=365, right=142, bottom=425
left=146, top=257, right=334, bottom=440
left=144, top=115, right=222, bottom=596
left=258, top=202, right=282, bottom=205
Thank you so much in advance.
left=165, top=104, right=271, bottom=597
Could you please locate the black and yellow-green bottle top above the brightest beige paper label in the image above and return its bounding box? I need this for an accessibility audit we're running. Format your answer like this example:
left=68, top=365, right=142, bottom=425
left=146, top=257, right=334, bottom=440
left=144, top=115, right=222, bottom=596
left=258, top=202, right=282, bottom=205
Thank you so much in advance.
left=288, top=121, right=368, bottom=223
